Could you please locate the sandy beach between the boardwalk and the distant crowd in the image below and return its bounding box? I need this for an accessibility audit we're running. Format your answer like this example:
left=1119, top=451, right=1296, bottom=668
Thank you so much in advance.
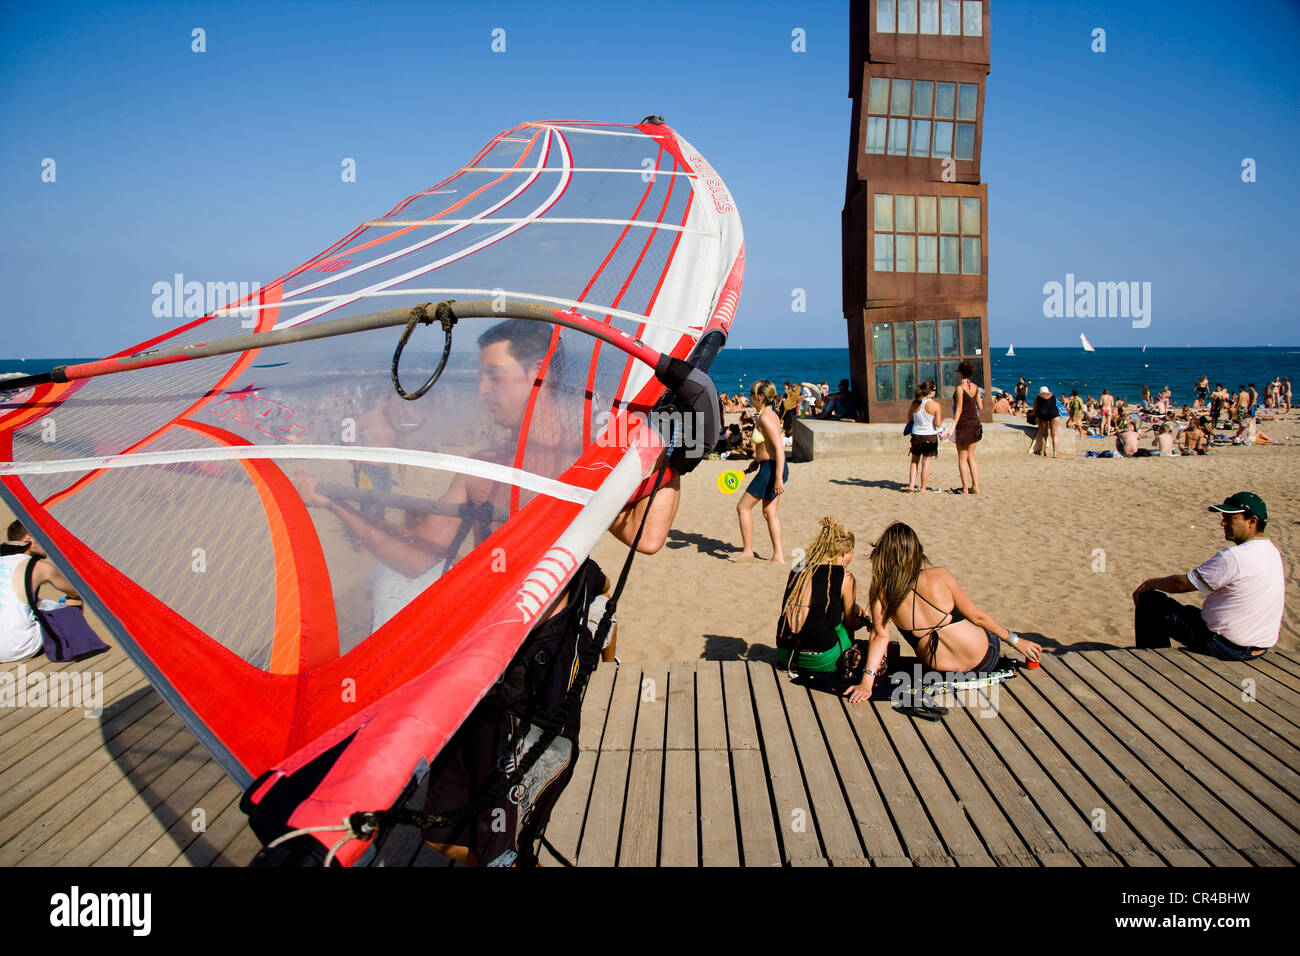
left=593, top=411, right=1300, bottom=661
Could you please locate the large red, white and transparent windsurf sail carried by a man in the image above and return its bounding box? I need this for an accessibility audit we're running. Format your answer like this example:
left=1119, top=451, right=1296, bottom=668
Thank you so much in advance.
left=0, top=117, right=745, bottom=864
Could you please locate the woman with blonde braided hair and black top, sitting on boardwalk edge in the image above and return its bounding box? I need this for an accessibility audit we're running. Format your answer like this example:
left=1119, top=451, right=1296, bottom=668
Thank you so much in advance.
left=776, top=518, right=866, bottom=674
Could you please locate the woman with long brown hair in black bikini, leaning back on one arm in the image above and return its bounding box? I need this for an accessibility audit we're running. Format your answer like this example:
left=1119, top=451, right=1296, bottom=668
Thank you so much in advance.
left=844, top=522, right=1043, bottom=704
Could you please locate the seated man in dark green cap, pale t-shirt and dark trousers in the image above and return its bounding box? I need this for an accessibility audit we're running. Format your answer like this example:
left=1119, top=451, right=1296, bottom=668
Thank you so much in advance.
left=1134, top=492, right=1286, bottom=661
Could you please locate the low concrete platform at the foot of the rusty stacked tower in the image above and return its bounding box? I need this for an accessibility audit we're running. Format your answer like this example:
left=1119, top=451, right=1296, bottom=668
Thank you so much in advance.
left=792, top=415, right=1086, bottom=462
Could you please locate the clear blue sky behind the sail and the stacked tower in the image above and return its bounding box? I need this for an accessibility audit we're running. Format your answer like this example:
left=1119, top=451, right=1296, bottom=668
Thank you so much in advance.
left=0, top=0, right=1300, bottom=356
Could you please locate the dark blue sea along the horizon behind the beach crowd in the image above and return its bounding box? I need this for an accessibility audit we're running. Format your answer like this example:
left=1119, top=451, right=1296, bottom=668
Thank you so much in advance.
left=0, top=347, right=1300, bottom=405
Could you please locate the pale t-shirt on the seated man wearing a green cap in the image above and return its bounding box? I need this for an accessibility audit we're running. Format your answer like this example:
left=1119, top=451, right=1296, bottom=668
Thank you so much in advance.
left=1187, top=537, right=1286, bottom=648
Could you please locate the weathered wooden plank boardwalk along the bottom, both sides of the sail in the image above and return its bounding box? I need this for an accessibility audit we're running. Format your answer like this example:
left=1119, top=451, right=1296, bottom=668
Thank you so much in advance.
left=0, top=649, right=1300, bottom=866
